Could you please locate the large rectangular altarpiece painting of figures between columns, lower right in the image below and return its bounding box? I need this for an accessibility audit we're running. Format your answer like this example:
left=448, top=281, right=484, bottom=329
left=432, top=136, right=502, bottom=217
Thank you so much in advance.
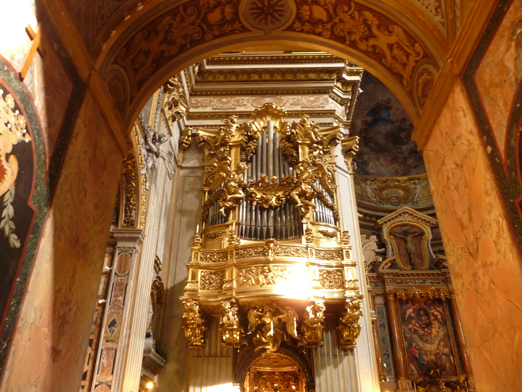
left=398, top=297, right=458, bottom=378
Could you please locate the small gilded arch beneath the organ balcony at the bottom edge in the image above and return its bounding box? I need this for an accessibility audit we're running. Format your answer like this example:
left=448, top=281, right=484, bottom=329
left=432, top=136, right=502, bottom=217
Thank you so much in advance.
left=234, top=345, right=315, bottom=392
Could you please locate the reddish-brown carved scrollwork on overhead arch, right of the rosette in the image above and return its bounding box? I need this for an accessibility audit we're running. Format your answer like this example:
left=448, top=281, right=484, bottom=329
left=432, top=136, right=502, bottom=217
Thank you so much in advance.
left=291, top=0, right=424, bottom=91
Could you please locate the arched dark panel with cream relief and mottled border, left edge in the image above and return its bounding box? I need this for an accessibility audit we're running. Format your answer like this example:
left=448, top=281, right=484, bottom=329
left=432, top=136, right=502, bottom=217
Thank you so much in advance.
left=0, top=62, right=47, bottom=368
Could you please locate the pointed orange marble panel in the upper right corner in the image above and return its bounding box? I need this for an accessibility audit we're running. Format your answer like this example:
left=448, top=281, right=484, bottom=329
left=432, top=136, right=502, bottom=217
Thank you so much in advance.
left=475, top=0, right=522, bottom=161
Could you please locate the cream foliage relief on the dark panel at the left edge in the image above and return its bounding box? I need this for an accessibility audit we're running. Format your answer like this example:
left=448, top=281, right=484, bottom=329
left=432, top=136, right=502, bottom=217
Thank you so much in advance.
left=0, top=90, right=31, bottom=249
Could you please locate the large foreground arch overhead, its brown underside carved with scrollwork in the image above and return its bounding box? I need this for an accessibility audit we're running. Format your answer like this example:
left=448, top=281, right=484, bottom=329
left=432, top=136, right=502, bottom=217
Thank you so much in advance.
left=97, top=0, right=443, bottom=127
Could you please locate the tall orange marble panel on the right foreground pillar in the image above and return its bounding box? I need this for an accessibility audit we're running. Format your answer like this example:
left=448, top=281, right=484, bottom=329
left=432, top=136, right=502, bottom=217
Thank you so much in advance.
left=424, top=83, right=522, bottom=392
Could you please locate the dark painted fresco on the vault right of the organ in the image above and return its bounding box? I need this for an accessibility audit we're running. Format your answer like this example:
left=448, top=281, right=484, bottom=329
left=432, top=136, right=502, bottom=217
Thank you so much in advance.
left=350, top=72, right=426, bottom=177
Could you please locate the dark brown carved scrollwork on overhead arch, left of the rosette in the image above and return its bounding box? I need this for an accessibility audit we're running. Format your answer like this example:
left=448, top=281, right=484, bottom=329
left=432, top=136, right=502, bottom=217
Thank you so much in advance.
left=117, top=0, right=244, bottom=96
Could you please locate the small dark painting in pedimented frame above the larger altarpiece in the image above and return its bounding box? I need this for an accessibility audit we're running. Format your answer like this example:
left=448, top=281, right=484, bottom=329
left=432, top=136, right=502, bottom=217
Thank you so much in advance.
left=388, top=223, right=430, bottom=270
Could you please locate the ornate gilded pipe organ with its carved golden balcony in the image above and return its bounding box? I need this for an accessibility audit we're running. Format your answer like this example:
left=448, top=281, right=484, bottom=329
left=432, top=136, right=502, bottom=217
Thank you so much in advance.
left=181, top=104, right=362, bottom=390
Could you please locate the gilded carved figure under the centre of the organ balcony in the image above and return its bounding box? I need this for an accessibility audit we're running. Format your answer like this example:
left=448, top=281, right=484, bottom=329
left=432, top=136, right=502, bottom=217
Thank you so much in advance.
left=248, top=304, right=299, bottom=353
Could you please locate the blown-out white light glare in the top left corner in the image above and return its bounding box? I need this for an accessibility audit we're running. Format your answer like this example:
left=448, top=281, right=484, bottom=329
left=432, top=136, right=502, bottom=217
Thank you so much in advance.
left=0, top=0, right=37, bottom=56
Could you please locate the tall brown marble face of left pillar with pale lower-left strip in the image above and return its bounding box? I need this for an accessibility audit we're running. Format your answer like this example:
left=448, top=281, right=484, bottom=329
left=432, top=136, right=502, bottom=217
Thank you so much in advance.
left=0, top=91, right=122, bottom=392
